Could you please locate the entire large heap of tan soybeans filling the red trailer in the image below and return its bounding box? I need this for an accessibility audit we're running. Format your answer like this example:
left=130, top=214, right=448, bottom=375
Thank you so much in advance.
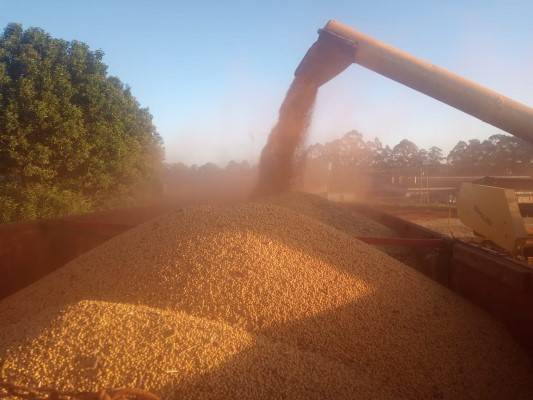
left=0, top=195, right=533, bottom=399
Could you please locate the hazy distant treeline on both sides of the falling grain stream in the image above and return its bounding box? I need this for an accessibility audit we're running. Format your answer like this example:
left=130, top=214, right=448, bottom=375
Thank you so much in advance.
left=163, top=131, right=533, bottom=197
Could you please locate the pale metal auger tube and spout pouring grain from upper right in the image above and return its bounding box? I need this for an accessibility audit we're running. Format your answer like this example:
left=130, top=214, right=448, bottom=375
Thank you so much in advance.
left=295, top=20, right=533, bottom=142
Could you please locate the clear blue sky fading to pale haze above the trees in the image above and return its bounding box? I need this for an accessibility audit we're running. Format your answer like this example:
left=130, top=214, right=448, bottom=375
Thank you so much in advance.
left=0, top=0, right=533, bottom=165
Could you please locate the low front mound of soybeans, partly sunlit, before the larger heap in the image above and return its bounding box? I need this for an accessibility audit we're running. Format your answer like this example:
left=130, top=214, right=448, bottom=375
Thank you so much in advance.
left=3, top=301, right=369, bottom=399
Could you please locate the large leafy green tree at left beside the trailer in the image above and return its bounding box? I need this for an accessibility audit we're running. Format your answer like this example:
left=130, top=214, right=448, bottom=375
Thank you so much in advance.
left=0, top=24, right=163, bottom=222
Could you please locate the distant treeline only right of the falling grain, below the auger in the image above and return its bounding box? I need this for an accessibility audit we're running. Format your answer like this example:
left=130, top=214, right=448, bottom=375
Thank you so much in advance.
left=299, top=131, right=533, bottom=175
